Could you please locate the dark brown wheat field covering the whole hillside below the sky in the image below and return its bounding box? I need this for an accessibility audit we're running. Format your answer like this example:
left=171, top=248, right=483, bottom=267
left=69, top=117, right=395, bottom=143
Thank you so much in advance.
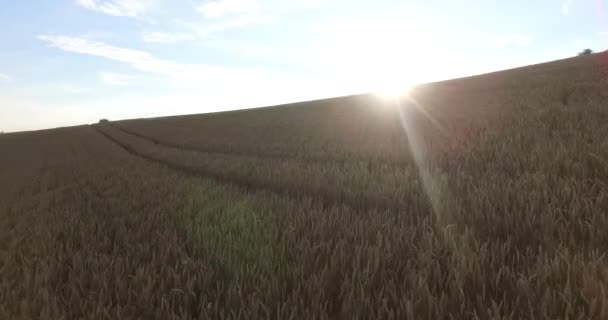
left=0, top=54, right=608, bottom=319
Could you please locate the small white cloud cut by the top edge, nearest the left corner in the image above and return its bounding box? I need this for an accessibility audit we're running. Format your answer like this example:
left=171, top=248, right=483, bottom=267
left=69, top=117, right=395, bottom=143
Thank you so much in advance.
left=76, top=0, right=154, bottom=17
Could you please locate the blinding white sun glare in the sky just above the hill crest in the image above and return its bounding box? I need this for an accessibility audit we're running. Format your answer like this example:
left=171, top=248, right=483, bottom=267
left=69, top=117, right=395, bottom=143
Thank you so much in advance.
left=324, top=20, right=433, bottom=100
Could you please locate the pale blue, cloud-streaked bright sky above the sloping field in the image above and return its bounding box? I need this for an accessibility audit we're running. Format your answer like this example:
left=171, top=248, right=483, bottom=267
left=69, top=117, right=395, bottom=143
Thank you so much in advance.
left=0, top=0, right=608, bottom=132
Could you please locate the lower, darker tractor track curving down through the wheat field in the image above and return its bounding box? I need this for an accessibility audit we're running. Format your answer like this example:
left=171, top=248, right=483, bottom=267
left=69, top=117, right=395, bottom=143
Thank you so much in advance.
left=92, top=125, right=418, bottom=211
